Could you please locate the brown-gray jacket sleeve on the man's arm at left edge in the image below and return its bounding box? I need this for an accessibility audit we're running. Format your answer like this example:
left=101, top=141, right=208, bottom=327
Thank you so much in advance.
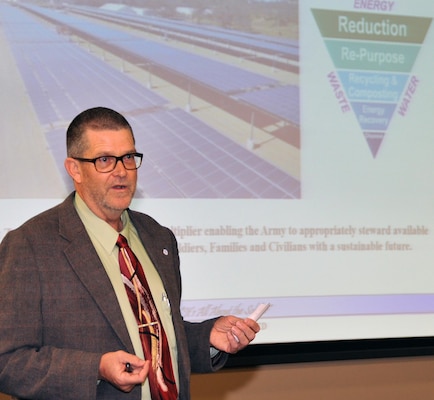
left=0, top=229, right=101, bottom=400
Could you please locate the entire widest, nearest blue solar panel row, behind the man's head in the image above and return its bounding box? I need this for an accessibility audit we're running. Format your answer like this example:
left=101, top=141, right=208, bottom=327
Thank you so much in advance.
left=0, top=5, right=300, bottom=198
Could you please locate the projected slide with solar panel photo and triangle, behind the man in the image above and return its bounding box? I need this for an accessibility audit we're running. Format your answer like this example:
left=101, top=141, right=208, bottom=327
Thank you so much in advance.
left=0, top=0, right=434, bottom=343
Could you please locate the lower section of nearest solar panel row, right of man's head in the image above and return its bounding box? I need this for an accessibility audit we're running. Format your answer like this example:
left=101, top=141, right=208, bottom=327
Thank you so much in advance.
left=134, top=109, right=300, bottom=198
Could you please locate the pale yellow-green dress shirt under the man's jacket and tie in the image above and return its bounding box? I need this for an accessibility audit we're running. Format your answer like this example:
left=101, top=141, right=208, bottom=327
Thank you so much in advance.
left=74, top=193, right=179, bottom=400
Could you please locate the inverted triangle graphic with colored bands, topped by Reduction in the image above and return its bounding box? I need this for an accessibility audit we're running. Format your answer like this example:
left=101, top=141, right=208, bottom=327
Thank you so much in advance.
left=312, top=9, right=432, bottom=158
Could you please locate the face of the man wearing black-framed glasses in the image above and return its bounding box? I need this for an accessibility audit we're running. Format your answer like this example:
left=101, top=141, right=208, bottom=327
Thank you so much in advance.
left=76, top=129, right=137, bottom=225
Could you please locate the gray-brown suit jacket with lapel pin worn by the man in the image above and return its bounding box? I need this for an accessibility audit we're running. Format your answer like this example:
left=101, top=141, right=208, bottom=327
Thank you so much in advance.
left=0, top=194, right=227, bottom=400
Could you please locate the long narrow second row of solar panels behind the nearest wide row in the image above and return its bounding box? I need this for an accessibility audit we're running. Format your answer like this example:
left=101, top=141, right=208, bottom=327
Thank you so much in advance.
left=25, top=7, right=300, bottom=143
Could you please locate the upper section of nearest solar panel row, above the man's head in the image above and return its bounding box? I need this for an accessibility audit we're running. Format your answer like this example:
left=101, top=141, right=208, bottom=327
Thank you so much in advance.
left=5, top=19, right=167, bottom=125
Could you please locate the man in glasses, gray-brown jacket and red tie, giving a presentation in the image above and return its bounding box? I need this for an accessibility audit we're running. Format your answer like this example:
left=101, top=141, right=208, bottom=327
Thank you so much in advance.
left=0, top=107, right=259, bottom=400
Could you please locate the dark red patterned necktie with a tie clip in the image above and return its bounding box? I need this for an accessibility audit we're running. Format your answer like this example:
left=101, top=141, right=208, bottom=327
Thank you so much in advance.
left=116, top=235, right=178, bottom=400
